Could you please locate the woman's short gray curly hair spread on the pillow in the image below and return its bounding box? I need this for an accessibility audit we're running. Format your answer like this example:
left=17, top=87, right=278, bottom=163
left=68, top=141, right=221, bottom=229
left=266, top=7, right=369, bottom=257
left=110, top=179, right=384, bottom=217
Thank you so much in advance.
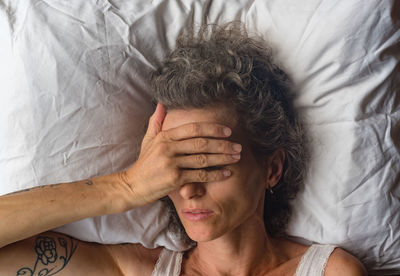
left=151, top=22, right=307, bottom=239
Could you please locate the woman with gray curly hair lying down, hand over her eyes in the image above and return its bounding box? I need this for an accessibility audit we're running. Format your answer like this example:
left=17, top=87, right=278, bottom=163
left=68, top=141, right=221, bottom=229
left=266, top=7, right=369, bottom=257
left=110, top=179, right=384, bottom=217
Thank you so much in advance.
left=0, top=25, right=366, bottom=276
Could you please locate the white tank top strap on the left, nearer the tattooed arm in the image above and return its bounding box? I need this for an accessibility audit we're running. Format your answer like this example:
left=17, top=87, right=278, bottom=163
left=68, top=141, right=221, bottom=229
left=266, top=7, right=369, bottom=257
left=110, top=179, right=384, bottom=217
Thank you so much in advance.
left=151, top=248, right=183, bottom=276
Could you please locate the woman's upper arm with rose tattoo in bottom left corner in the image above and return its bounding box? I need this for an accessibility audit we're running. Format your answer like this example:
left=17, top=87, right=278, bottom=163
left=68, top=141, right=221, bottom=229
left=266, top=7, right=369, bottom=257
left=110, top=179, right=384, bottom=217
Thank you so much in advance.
left=0, top=232, right=139, bottom=276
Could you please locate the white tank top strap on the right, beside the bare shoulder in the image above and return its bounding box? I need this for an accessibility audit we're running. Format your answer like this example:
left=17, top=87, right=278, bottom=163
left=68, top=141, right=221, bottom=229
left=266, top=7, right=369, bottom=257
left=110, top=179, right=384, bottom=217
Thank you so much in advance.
left=295, top=244, right=337, bottom=276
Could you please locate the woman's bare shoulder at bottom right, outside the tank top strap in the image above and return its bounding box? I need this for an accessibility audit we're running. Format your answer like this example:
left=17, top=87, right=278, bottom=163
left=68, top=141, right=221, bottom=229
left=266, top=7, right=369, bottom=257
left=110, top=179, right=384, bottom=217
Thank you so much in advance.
left=325, top=248, right=368, bottom=276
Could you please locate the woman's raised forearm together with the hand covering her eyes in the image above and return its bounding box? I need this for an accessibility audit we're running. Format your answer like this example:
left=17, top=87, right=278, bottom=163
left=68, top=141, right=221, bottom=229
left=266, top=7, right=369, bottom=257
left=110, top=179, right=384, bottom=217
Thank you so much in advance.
left=0, top=105, right=238, bottom=247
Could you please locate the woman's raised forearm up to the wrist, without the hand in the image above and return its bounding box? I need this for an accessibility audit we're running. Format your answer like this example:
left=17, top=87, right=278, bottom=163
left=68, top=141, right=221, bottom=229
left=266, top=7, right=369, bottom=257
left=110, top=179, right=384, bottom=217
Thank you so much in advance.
left=0, top=172, right=133, bottom=247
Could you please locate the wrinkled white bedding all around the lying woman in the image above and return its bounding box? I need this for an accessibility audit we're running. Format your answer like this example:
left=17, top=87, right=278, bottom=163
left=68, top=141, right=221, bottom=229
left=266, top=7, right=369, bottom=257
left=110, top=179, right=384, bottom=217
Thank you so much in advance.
left=0, top=0, right=400, bottom=275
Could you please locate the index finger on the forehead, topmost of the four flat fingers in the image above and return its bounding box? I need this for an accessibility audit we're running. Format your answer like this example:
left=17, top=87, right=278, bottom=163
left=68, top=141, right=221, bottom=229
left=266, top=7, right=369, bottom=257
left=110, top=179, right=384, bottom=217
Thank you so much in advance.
left=162, top=122, right=232, bottom=140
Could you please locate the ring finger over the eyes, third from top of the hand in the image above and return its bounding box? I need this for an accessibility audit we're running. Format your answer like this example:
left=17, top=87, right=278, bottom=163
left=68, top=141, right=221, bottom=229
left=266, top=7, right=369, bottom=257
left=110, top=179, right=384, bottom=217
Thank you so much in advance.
left=176, top=154, right=240, bottom=169
